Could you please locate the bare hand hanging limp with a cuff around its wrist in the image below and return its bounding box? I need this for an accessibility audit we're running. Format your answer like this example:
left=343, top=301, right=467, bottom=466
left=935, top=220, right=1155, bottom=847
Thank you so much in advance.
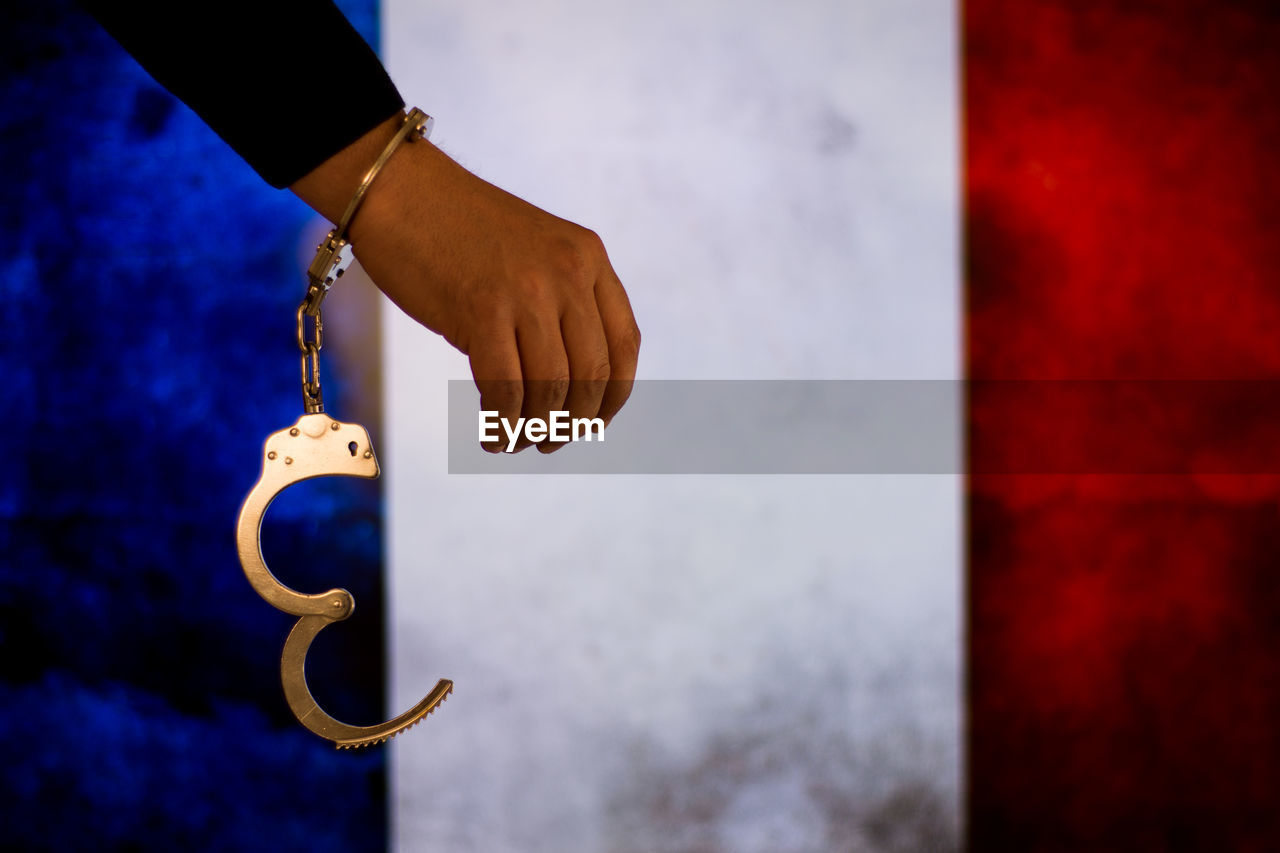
left=292, top=112, right=640, bottom=452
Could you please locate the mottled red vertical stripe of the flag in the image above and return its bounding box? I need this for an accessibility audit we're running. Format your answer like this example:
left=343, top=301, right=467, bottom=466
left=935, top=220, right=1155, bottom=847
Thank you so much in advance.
left=964, top=0, right=1280, bottom=850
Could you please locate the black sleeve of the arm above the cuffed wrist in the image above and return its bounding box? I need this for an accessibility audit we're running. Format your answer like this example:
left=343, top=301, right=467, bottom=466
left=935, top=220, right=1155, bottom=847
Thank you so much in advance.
left=81, top=0, right=404, bottom=187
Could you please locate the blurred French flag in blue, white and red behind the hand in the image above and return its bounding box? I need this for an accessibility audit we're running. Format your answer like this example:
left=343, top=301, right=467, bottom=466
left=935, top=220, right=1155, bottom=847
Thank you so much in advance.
left=0, top=0, right=1280, bottom=853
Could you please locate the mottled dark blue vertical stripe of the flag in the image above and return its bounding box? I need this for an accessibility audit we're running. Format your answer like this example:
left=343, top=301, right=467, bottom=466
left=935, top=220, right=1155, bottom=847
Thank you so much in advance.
left=0, top=0, right=387, bottom=850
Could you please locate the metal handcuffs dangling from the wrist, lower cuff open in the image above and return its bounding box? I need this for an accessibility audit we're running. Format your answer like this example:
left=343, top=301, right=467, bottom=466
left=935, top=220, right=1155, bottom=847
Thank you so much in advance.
left=236, top=108, right=453, bottom=749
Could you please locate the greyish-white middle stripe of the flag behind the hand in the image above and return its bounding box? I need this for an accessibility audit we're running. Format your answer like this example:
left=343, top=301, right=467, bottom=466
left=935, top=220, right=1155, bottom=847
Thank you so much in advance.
left=380, top=0, right=961, bottom=853
